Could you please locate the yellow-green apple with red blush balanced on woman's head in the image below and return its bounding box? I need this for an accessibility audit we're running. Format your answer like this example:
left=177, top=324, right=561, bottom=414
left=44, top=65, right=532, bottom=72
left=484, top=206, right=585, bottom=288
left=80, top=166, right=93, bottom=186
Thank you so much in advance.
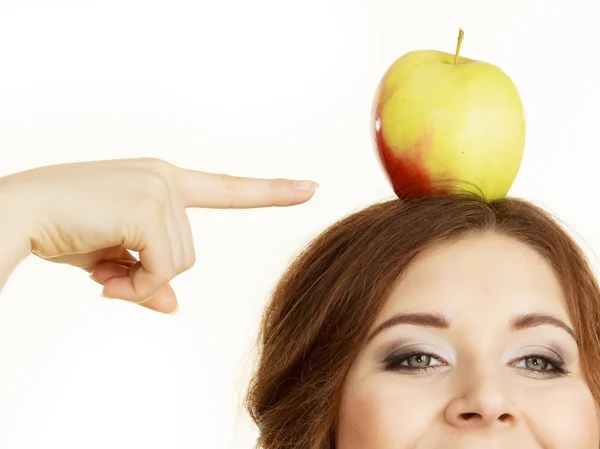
left=372, top=29, right=525, bottom=200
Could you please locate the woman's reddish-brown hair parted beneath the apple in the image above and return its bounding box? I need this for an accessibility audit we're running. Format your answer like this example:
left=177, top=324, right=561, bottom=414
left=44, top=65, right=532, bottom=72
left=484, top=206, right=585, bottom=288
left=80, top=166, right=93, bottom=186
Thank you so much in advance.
left=246, top=195, right=600, bottom=449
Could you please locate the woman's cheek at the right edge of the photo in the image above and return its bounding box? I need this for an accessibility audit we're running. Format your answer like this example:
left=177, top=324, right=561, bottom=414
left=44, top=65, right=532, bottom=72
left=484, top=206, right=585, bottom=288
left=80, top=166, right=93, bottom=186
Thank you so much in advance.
left=519, top=381, right=600, bottom=449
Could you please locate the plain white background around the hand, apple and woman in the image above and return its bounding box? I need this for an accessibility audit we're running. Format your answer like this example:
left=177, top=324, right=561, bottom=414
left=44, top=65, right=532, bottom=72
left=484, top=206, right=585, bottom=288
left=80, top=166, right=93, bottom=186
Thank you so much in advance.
left=0, top=0, right=600, bottom=449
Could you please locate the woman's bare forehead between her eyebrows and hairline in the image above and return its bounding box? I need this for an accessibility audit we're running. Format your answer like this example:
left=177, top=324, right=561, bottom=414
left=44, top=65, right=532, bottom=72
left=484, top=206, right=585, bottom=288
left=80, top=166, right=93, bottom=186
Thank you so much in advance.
left=381, top=233, right=570, bottom=322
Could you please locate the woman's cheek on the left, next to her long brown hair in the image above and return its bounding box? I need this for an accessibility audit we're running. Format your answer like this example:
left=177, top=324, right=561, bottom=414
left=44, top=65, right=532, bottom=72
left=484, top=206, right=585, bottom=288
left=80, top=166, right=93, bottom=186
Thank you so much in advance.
left=336, top=375, right=436, bottom=449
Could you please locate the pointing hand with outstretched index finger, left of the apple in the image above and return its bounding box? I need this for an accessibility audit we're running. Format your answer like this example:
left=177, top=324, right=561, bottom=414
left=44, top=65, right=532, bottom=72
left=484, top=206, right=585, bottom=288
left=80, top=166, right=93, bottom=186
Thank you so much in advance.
left=0, top=159, right=317, bottom=313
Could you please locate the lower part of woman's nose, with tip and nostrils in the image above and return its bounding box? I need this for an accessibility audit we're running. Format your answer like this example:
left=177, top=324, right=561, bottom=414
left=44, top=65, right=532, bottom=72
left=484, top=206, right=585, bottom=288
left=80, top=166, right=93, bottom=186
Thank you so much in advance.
left=444, top=374, right=517, bottom=429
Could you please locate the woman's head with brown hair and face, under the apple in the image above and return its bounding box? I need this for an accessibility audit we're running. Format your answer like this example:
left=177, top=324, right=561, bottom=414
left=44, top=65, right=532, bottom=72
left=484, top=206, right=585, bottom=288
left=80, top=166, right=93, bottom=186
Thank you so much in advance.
left=247, top=196, right=600, bottom=449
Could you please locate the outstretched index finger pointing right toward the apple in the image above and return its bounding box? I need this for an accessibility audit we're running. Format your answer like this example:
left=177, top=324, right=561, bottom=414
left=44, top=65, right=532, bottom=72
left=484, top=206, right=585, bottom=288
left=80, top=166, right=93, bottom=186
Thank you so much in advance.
left=176, top=167, right=319, bottom=209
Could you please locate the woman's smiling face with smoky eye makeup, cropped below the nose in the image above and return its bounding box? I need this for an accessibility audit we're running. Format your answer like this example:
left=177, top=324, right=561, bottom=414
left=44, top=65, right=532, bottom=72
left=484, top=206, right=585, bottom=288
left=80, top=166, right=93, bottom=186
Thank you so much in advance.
left=336, top=234, right=600, bottom=449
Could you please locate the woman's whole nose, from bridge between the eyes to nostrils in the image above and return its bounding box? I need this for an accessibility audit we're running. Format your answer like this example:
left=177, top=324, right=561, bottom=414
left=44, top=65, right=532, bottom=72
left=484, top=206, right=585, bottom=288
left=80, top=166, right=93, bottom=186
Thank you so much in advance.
left=446, top=348, right=515, bottom=427
